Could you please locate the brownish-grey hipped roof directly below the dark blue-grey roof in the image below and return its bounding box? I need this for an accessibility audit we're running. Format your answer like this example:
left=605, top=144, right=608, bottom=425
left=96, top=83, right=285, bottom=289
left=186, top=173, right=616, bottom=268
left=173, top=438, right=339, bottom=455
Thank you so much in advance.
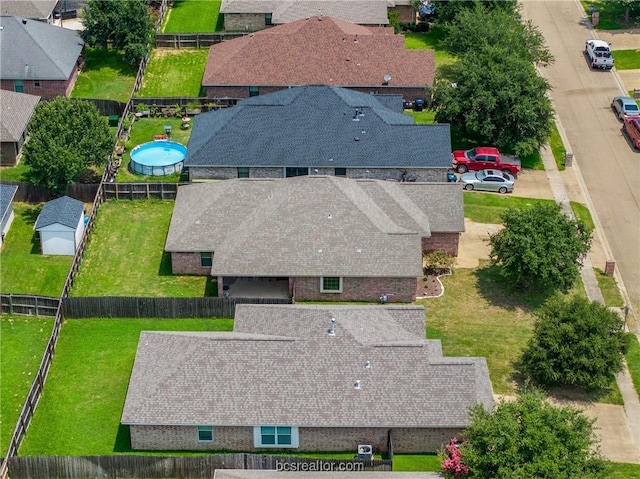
left=165, top=176, right=464, bottom=277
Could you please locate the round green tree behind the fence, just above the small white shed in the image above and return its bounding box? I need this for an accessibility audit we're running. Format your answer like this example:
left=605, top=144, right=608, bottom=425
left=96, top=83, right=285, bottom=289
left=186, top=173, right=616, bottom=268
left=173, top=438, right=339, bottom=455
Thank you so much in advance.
left=23, top=97, right=113, bottom=193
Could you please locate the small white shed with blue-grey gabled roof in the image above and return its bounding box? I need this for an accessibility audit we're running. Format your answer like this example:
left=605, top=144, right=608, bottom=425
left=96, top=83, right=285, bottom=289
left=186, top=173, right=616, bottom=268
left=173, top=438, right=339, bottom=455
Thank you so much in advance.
left=33, top=196, right=84, bottom=256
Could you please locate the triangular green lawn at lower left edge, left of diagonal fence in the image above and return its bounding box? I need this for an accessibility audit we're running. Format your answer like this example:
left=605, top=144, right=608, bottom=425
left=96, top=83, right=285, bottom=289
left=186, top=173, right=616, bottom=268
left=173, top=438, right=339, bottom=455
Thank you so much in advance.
left=0, top=315, right=53, bottom=455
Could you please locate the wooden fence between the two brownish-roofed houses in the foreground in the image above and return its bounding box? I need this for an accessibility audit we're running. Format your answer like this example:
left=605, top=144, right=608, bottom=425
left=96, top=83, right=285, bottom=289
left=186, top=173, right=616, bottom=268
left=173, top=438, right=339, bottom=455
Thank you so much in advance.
left=62, top=296, right=291, bottom=318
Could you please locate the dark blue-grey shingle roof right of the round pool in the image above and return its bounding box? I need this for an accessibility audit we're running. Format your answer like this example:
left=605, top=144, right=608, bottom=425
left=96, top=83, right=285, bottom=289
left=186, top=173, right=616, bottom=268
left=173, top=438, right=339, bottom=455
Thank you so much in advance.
left=185, top=85, right=451, bottom=169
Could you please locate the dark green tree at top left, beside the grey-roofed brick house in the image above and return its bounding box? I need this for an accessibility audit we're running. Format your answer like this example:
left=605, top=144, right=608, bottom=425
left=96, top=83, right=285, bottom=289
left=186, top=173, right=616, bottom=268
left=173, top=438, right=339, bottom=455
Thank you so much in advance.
left=81, top=0, right=154, bottom=64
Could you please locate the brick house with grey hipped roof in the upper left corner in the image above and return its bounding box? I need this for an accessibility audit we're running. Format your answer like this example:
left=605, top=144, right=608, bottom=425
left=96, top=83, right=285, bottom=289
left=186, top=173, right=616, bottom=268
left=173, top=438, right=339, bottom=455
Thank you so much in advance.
left=0, top=15, right=84, bottom=98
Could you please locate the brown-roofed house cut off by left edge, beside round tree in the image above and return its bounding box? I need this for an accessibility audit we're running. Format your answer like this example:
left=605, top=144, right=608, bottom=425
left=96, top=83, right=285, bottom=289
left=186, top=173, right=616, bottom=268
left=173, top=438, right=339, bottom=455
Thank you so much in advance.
left=0, top=90, right=40, bottom=166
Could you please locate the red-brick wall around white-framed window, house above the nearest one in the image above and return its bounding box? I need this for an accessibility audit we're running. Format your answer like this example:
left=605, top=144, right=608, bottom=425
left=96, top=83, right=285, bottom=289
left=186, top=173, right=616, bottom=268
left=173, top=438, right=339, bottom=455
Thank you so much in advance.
left=295, top=277, right=416, bottom=303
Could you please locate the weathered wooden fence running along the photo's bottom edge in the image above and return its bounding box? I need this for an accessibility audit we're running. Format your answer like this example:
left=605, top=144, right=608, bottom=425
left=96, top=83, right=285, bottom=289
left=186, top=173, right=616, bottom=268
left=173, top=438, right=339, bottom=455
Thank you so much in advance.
left=9, top=453, right=392, bottom=479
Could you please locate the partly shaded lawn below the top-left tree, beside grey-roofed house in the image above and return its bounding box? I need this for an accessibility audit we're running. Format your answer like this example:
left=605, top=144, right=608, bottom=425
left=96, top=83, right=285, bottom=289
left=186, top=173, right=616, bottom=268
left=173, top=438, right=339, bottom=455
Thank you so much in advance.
left=71, top=47, right=138, bottom=103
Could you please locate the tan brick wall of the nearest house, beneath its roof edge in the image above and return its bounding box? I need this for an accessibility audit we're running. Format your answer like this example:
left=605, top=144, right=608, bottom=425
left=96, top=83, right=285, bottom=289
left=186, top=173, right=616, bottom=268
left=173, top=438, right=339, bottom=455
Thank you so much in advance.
left=130, top=425, right=452, bottom=455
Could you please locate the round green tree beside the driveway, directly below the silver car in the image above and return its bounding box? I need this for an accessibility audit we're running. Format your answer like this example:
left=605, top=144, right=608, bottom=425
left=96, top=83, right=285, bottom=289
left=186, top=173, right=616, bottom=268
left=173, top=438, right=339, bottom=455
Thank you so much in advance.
left=489, top=203, right=591, bottom=291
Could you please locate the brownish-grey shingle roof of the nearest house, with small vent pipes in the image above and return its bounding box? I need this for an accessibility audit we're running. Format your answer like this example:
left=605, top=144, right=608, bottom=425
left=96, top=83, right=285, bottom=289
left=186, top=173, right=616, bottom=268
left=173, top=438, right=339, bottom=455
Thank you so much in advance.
left=122, top=305, right=493, bottom=427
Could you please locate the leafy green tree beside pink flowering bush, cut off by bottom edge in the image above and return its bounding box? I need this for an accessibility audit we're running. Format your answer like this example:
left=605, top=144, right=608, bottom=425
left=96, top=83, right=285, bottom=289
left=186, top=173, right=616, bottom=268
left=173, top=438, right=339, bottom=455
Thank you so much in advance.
left=460, top=390, right=608, bottom=479
